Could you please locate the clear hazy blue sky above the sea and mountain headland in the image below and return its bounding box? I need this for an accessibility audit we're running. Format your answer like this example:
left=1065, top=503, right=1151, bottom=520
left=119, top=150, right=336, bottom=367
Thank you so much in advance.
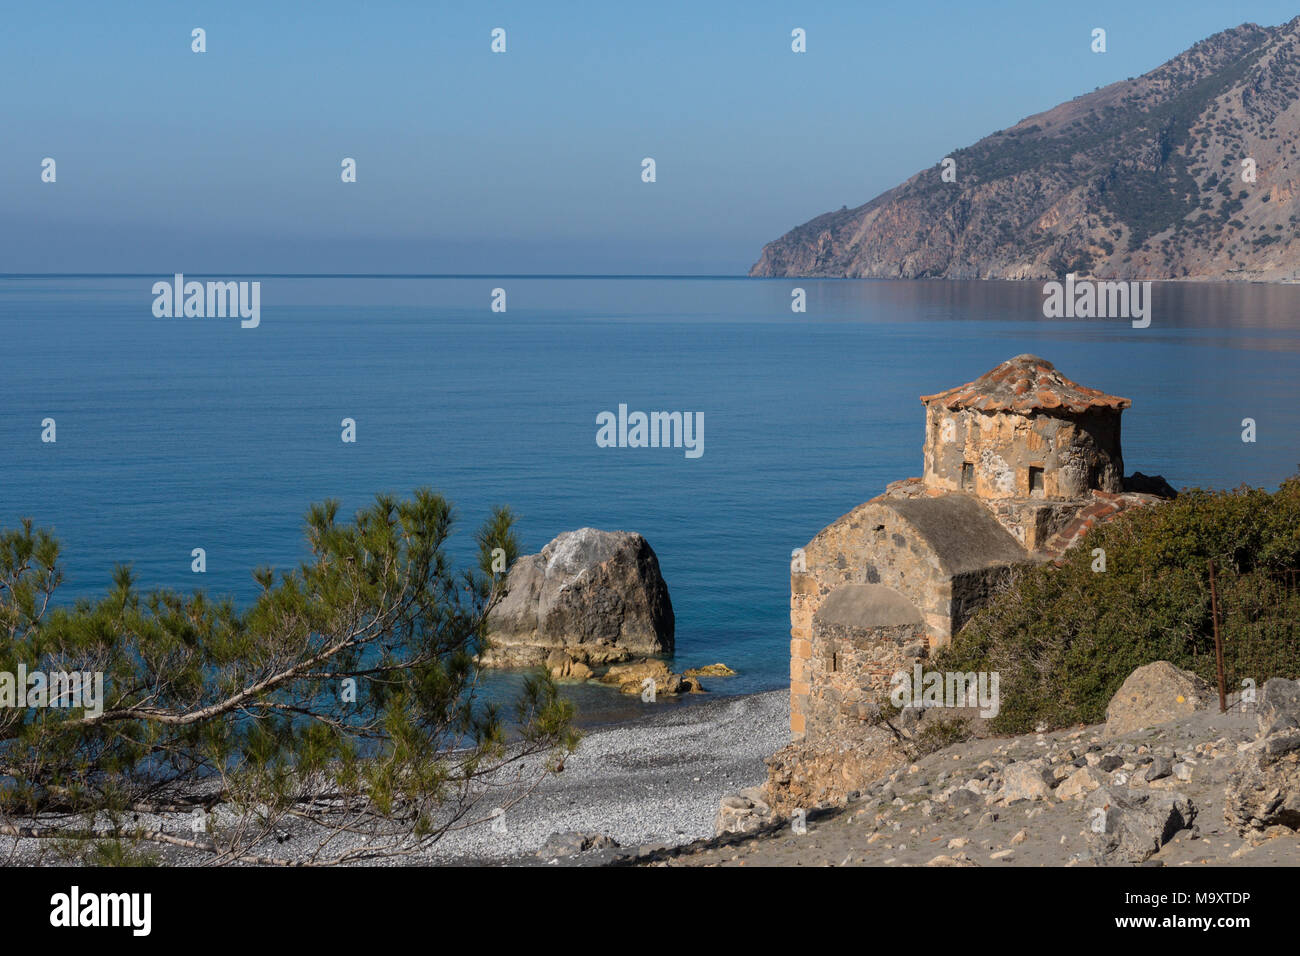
left=10, top=0, right=1296, bottom=273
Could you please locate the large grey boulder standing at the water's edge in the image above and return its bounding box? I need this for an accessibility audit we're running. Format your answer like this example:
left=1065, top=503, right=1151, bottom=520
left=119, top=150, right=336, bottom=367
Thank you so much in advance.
left=484, top=528, right=675, bottom=667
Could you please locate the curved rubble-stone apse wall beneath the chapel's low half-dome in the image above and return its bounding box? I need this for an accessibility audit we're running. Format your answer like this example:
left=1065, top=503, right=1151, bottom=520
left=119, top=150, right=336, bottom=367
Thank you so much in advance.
left=805, top=619, right=927, bottom=737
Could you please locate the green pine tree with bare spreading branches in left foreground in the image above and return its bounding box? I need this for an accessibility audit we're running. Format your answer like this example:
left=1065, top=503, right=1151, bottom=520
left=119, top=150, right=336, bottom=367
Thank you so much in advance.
left=0, top=489, right=576, bottom=864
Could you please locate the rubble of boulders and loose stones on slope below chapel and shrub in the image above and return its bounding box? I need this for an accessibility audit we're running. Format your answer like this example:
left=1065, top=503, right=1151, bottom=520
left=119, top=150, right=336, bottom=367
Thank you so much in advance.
left=715, top=662, right=1300, bottom=866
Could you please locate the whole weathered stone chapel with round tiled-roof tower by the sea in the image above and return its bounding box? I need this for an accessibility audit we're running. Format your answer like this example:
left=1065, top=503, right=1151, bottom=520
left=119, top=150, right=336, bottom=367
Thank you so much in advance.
left=790, top=355, right=1175, bottom=739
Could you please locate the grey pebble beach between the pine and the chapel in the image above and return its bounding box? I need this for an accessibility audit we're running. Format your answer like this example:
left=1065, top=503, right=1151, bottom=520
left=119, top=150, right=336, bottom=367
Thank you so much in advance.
left=0, top=691, right=789, bottom=866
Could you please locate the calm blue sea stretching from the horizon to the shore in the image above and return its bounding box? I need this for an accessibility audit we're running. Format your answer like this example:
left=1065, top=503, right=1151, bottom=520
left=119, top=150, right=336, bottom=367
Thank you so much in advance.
left=0, top=274, right=1300, bottom=714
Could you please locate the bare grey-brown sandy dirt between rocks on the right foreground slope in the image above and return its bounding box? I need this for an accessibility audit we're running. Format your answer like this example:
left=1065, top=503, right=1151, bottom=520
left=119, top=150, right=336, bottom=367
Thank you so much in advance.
left=640, top=710, right=1300, bottom=866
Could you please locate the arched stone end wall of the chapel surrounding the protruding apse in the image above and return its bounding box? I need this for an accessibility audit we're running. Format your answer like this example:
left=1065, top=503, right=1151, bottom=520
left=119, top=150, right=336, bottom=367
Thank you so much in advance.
left=790, top=502, right=953, bottom=736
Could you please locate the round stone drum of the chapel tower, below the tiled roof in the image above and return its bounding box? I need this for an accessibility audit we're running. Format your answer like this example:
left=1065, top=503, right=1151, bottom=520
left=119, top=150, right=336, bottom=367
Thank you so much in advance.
left=923, top=402, right=1123, bottom=499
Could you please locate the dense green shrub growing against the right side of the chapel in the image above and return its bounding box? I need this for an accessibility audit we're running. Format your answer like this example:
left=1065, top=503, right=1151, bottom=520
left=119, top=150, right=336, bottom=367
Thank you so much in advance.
left=936, top=476, right=1300, bottom=734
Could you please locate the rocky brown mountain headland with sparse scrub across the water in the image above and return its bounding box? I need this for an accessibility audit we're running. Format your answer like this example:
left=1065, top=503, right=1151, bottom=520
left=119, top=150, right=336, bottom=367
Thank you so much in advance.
left=750, top=17, right=1300, bottom=281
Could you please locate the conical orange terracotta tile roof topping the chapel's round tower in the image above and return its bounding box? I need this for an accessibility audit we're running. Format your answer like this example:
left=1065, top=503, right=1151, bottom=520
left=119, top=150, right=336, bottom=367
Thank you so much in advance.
left=920, top=355, right=1132, bottom=414
